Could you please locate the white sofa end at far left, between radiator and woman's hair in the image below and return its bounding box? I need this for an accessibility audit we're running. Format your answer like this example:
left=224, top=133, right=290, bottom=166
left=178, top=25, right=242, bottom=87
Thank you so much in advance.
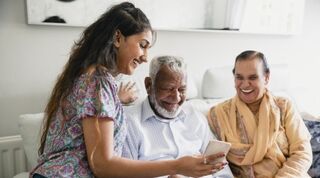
left=19, top=113, right=44, bottom=168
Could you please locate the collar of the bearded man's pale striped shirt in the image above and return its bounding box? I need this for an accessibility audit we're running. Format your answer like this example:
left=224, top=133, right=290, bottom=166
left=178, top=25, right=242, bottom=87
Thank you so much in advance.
left=141, top=97, right=186, bottom=122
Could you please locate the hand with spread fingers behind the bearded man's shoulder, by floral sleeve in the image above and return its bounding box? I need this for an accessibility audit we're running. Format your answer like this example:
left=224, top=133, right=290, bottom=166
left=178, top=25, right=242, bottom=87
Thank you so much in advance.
left=118, top=82, right=138, bottom=104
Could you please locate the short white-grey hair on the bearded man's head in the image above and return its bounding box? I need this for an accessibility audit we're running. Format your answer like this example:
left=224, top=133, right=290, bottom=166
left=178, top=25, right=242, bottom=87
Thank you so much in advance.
left=149, top=56, right=187, bottom=84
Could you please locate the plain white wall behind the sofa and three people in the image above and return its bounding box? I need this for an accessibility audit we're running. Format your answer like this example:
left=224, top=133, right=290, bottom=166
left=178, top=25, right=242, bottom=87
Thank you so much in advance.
left=0, top=0, right=320, bottom=136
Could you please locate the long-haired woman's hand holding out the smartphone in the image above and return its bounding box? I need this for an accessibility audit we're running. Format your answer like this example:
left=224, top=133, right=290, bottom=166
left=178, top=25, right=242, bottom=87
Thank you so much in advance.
left=177, top=153, right=227, bottom=177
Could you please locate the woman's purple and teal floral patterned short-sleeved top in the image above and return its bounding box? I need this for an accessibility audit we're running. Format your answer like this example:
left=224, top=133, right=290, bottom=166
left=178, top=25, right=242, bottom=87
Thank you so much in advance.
left=31, top=74, right=127, bottom=177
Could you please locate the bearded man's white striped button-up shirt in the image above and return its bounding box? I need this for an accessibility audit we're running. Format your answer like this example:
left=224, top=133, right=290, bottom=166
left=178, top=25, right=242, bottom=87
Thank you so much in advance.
left=123, top=99, right=233, bottom=178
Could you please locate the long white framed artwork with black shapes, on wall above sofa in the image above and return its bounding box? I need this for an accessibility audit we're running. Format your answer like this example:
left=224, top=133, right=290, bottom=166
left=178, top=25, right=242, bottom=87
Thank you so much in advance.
left=26, top=0, right=305, bottom=34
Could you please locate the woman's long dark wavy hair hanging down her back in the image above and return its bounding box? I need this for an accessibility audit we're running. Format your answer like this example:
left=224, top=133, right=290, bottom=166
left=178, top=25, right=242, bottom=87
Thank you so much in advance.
left=38, top=2, right=152, bottom=154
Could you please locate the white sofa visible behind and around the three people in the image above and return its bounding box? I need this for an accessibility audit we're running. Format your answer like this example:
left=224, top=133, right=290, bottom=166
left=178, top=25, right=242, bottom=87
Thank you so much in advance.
left=14, top=65, right=317, bottom=178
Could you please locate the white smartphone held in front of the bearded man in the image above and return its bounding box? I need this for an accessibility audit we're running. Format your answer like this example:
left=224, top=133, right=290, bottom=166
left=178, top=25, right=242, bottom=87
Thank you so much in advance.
left=204, top=140, right=231, bottom=164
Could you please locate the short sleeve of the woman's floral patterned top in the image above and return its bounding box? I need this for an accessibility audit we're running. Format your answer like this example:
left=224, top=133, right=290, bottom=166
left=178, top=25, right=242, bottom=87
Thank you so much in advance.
left=74, top=75, right=120, bottom=119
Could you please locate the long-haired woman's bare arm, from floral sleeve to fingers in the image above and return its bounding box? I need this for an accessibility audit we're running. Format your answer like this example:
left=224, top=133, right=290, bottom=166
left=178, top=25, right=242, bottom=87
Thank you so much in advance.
left=82, top=118, right=216, bottom=178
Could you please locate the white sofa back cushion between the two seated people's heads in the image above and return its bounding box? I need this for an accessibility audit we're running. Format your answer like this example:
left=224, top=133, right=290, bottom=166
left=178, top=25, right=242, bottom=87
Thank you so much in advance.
left=202, top=66, right=236, bottom=99
